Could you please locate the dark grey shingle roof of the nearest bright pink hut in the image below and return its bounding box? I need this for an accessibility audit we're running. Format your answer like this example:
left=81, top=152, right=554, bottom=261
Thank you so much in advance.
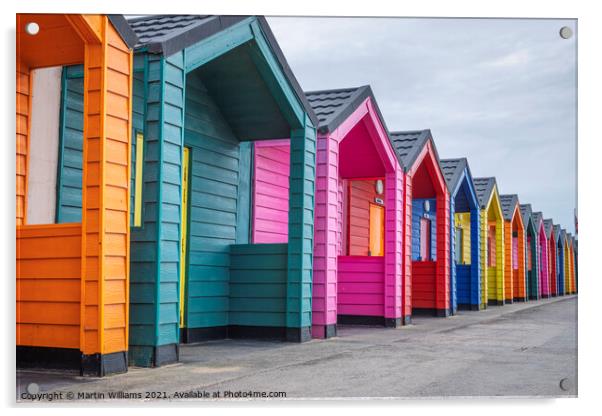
left=305, top=85, right=387, bottom=133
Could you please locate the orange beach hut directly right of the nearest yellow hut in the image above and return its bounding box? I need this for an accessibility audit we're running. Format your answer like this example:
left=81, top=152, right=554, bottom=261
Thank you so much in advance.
left=500, top=194, right=527, bottom=303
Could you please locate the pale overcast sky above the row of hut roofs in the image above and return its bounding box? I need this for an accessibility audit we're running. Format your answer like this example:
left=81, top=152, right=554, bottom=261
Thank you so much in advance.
left=268, top=17, right=577, bottom=233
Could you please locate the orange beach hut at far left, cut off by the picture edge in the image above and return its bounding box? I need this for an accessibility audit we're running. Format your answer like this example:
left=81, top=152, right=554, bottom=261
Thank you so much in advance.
left=16, top=14, right=136, bottom=376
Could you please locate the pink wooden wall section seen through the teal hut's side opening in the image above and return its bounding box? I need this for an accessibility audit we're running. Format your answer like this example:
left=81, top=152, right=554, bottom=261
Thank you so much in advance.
left=252, top=140, right=290, bottom=243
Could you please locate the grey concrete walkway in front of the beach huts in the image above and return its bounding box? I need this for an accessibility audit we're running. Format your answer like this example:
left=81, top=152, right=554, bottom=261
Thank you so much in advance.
left=17, top=296, right=577, bottom=400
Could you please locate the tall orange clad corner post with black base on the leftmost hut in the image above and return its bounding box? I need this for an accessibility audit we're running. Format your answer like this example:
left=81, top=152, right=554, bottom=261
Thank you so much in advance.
left=80, top=17, right=132, bottom=376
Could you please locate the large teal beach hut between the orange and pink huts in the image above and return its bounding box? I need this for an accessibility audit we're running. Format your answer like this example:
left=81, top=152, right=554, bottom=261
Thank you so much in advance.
left=55, top=15, right=317, bottom=366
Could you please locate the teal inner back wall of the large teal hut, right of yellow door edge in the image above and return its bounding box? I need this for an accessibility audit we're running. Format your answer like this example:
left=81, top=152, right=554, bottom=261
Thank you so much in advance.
left=184, top=73, right=240, bottom=328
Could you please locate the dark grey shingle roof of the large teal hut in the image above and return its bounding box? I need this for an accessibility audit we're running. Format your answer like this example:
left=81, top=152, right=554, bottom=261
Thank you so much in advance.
left=128, top=14, right=318, bottom=127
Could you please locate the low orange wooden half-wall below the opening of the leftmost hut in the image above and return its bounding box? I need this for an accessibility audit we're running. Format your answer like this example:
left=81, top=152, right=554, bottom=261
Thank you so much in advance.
left=16, top=224, right=81, bottom=348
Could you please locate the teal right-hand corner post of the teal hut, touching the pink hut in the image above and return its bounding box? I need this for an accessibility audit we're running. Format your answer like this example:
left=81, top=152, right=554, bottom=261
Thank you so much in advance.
left=286, top=114, right=316, bottom=342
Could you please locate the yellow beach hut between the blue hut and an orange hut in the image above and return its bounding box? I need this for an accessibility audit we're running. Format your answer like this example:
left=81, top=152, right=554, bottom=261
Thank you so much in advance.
left=474, top=177, right=505, bottom=306
